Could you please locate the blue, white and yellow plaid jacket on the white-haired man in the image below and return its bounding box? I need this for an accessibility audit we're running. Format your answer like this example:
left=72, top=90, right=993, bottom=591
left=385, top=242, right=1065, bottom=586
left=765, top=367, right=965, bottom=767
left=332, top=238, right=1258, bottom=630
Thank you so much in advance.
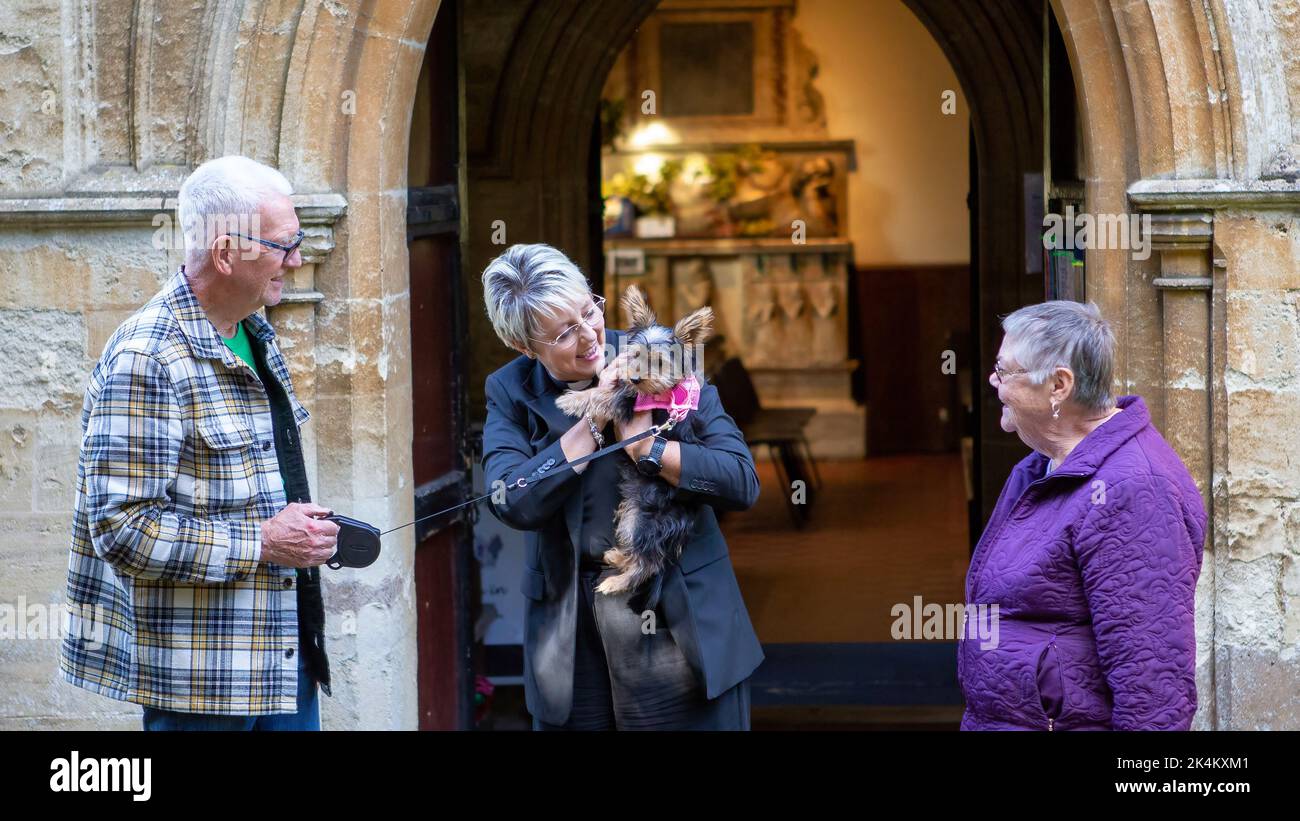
left=60, top=272, right=308, bottom=716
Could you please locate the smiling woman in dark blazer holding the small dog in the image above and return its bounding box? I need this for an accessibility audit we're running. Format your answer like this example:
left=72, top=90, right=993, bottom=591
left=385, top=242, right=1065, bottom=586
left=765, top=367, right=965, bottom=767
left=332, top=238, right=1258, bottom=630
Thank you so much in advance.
left=482, top=244, right=763, bottom=730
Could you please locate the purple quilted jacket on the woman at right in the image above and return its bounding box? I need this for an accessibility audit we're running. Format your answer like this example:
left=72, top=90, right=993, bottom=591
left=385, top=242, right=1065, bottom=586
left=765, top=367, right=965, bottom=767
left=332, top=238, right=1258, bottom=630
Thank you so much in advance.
left=957, top=396, right=1206, bottom=730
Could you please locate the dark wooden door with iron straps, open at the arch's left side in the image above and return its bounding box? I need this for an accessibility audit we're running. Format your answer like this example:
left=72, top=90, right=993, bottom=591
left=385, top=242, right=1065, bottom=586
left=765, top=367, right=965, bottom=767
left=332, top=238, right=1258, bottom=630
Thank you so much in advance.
left=407, top=0, right=475, bottom=730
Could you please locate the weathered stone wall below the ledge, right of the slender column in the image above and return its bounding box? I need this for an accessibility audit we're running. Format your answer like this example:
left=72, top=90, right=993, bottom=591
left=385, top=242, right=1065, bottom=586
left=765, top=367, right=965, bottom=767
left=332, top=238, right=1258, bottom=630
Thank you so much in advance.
left=1213, top=209, right=1300, bottom=729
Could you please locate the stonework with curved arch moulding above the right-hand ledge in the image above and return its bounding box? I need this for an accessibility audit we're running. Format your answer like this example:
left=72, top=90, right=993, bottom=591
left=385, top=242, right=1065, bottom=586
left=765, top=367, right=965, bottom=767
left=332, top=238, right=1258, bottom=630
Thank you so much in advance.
left=1052, top=0, right=1300, bottom=182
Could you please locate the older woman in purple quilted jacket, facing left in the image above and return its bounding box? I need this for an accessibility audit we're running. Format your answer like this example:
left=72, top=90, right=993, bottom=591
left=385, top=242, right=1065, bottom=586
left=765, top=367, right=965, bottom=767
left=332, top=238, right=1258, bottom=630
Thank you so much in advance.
left=958, top=301, right=1206, bottom=730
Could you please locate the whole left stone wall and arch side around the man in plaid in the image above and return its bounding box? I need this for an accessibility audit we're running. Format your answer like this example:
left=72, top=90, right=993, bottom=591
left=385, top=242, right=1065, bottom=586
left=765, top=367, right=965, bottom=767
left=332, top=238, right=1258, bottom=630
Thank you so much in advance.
left=0, top=0, right=438, bottom=729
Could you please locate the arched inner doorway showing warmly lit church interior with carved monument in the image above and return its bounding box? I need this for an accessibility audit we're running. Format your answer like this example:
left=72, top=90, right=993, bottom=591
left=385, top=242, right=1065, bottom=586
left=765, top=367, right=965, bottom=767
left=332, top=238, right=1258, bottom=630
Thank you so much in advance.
left=593, top=0, right=980, bottom=726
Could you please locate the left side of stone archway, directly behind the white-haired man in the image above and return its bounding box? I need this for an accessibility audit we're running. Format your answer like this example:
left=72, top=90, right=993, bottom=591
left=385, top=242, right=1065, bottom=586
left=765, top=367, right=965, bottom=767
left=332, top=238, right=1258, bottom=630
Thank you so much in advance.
left=175, top=0, right=439, bottom=729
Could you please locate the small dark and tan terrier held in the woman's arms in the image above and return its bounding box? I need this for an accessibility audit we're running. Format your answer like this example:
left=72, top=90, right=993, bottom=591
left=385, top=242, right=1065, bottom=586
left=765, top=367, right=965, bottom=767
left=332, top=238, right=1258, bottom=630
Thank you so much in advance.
left=555, top=286, right=714, bottom=607
